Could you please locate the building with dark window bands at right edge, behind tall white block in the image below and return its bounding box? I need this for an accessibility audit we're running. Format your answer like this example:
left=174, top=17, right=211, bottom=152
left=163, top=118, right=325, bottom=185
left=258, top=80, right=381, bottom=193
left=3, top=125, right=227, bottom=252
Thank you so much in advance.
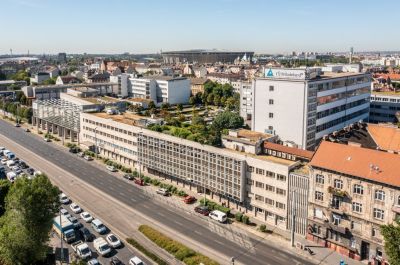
left=369, top=91, right=400, bottom=123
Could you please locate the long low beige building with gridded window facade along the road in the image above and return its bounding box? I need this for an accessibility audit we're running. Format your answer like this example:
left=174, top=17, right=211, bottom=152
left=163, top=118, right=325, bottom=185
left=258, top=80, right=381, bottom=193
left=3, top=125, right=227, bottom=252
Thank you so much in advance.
left=80, top=110, right=307, bottom=234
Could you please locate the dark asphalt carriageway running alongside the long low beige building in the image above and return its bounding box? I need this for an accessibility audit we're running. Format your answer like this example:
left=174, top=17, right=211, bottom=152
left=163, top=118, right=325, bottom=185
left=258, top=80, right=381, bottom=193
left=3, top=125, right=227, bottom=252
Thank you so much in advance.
left=0, top=120, right=313, bottom=265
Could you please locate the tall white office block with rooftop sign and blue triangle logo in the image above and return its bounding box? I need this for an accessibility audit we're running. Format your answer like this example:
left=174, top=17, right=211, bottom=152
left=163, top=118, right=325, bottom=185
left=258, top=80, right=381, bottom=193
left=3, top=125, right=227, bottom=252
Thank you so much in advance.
left=252, top=68, right=371, bottom=149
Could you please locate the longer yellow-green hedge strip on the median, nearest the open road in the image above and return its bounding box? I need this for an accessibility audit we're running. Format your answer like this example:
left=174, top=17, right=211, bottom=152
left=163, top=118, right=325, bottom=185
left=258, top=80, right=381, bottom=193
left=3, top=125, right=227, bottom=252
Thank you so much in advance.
left=139, top=225, right=219, bottom=265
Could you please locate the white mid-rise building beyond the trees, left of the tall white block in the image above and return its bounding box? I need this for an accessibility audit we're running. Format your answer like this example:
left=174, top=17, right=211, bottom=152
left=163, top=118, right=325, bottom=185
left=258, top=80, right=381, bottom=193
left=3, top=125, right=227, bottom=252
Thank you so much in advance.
left=129, top=76, right=191, bottom=105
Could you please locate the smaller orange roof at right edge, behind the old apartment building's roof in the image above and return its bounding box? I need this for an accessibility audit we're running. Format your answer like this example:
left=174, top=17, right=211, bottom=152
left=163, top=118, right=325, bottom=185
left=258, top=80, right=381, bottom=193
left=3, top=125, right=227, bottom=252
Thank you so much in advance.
left=368, top=124, right=400, bottom=152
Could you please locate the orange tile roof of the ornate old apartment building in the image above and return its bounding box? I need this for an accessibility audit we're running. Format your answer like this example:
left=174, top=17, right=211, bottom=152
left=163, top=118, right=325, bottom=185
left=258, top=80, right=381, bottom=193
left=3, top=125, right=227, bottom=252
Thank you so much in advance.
left=309, top=141, right=400, bottom=187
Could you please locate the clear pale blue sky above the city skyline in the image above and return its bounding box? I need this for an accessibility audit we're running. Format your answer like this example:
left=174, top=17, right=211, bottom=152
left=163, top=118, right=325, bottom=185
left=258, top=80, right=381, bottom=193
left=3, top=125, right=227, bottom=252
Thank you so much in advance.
left=0, top=0, right=400, bottom=54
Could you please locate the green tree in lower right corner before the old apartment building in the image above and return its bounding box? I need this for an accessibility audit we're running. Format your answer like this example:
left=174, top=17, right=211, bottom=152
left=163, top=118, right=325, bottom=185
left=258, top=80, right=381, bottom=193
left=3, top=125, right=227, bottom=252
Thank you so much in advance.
left=381, top=220, right=400, bottom=265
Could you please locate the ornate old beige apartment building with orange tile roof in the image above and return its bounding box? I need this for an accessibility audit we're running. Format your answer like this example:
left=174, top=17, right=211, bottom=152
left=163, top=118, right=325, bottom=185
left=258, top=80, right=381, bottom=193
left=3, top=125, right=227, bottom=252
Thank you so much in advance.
left=307, top=141, right=400, bottom=264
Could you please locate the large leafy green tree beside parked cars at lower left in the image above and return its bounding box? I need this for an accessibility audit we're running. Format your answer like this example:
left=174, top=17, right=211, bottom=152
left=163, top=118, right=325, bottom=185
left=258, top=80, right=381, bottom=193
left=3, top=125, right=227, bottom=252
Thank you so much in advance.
left=0, top=175, right=60, bottom=264
